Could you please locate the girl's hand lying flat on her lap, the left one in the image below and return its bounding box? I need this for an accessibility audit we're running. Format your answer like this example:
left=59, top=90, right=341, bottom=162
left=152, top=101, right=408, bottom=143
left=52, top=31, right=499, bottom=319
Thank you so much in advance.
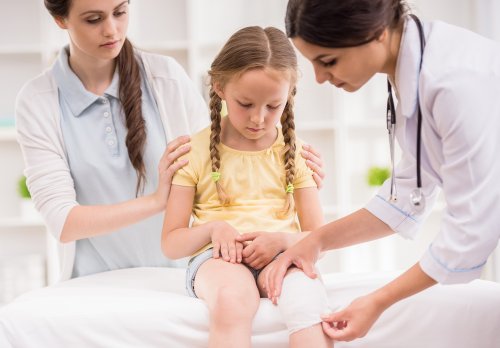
left=210, top=221, right=243, bottom=263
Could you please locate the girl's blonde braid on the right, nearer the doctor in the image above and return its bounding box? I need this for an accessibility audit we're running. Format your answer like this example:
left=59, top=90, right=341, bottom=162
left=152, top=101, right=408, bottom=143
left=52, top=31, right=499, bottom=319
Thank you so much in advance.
left=278, top=87, right=297, bottom=218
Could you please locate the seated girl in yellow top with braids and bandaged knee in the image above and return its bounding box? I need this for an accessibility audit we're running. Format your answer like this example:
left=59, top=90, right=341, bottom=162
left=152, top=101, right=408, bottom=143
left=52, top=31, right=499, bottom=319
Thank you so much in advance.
left=162, top=27, right=332, bottom=348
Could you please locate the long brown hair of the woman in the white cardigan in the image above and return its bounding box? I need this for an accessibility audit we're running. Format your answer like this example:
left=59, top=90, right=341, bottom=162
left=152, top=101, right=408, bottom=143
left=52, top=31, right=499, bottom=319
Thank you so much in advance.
left=44, top=0, right=146, bottom=196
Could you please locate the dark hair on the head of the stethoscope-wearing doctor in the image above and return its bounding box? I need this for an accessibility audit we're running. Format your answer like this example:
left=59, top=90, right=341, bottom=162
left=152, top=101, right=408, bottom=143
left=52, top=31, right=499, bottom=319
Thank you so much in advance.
left=285, top=0, right=409, bottom=48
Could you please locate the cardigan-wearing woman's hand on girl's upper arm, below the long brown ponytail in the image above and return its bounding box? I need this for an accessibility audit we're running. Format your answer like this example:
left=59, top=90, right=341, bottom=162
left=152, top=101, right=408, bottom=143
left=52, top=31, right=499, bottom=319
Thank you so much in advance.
left=153, top=135, right=191, bottom=211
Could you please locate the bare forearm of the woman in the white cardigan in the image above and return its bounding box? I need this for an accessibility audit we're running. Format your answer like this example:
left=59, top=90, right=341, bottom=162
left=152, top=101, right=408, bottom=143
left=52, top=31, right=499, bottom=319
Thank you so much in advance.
left=60, top=195, right=164, bottom=243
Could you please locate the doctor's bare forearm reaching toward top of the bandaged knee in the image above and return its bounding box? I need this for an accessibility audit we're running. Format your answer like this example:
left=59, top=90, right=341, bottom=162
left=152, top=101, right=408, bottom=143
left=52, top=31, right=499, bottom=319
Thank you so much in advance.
left=310, top=209, right=394, bottom=251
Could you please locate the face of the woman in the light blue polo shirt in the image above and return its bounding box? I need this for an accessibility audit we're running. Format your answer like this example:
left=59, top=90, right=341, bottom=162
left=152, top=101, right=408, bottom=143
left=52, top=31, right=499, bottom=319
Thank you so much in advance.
left=56, top=0, right=128, bottom=60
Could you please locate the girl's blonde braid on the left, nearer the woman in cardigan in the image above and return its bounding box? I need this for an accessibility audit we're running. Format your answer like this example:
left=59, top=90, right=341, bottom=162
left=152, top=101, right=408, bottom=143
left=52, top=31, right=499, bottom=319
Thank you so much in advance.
left=209, top=88, right=230, bottom=206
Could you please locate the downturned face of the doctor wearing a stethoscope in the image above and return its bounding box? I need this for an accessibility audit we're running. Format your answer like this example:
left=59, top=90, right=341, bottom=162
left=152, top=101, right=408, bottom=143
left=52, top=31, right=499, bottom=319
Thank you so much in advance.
left=292, top=31, right=389, bottom=92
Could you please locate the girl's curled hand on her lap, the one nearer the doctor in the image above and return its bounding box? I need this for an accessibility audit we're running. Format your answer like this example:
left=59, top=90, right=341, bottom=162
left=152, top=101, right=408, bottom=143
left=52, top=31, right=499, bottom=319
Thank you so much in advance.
left=236, top=232, right=287, bottom=269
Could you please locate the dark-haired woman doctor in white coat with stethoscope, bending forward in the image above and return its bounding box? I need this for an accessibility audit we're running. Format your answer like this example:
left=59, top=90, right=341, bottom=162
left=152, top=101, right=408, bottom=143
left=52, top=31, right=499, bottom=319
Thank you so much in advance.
left=267, top=0, right=500, bottom=341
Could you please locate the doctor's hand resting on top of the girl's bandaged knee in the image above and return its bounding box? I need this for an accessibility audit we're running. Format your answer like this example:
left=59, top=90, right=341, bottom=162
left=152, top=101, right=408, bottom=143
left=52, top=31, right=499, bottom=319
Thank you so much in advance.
left=265, top=232, right=321, bottom=304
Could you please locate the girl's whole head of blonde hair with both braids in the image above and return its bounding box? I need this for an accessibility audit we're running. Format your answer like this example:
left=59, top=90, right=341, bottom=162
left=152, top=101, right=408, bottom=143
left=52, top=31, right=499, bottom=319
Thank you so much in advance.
left=208, top=26, right=297, bottom=218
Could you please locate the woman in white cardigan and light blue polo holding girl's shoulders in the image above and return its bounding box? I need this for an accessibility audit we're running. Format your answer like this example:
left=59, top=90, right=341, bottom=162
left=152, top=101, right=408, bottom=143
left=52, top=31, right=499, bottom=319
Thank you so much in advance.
left=16, top=0, right=323, bottom=279
